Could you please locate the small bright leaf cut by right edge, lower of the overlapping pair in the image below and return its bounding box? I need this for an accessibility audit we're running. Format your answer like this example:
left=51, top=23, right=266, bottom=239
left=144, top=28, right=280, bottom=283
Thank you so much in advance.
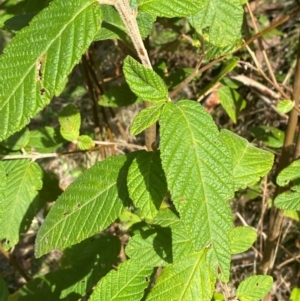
left=274, top=185, right=300, bottom=211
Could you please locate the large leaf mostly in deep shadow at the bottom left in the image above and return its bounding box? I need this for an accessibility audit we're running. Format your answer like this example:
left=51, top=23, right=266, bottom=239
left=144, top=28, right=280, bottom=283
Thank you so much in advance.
left=14, top=235, right=121, bottom=301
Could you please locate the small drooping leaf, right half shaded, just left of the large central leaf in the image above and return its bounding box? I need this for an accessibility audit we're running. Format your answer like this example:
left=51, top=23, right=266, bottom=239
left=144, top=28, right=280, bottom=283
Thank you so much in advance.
left=127, top=151, right=168, bottom=219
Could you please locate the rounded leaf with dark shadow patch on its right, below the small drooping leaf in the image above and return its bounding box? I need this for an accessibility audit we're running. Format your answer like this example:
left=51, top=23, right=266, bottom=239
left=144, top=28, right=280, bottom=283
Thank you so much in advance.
left=125, top=227, right=173, bottom=267
